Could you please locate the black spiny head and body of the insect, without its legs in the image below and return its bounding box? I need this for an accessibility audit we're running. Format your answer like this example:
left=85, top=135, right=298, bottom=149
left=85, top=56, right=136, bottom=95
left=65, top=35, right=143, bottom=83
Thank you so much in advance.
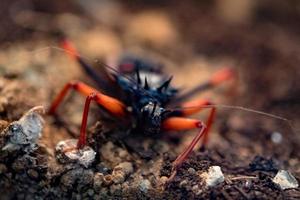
left=116, top=60, right=177, bottom=134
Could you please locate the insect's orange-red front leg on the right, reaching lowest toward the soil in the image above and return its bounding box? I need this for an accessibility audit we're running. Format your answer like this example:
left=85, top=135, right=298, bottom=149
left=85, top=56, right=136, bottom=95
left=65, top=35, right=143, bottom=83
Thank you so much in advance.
left=163, top=117, right=206, bottom=180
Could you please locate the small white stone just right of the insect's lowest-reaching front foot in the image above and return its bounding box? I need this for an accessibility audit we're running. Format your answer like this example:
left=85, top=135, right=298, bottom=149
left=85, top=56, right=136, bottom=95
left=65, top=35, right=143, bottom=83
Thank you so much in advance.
left=201, top=166, right=225, bottom=187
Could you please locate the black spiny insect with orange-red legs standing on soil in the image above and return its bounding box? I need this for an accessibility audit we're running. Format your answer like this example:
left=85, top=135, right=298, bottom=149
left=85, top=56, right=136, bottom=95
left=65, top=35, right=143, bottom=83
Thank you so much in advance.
left=49, top=40, right=235, bottom=180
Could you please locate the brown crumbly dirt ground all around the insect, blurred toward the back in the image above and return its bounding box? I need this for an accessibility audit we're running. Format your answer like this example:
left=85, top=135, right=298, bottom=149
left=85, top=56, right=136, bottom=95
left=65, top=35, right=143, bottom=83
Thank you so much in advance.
left=0, top=0, right=300, bottom=199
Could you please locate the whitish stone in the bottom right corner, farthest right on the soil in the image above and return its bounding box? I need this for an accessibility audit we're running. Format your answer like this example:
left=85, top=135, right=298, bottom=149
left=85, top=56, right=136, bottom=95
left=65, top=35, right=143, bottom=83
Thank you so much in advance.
left=273, top=170, right=299, bottom=190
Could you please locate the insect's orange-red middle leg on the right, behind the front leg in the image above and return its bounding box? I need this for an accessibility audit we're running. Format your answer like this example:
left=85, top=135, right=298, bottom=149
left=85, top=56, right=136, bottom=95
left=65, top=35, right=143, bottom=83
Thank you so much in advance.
left=180, top=99, right=216, bottom=148
